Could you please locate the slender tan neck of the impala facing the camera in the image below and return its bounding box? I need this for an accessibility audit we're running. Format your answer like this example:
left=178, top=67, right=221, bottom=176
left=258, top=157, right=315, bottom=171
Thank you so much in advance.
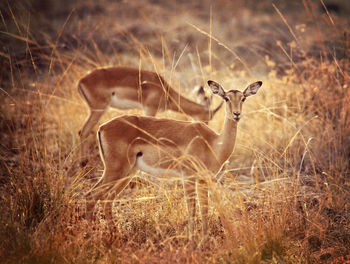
left=216, top=116, right=238, bottom=164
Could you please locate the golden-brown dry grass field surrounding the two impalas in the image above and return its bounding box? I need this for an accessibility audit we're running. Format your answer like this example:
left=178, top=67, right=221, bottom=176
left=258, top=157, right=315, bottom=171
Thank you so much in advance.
left=0, top=0, right=350, bottom=263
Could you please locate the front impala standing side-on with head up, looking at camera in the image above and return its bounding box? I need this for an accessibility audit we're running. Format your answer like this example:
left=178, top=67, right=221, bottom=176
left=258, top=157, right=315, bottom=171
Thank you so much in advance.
left=87, top=78, right=262, bottom=235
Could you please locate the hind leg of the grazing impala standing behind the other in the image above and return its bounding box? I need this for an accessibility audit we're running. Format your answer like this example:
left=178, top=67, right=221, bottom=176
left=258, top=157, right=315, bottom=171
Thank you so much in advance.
left=79, top=110, right=104, bottom=167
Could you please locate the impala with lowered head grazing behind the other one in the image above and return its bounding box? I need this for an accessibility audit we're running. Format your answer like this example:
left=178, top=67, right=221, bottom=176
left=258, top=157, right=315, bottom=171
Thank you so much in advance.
left=78, top=66, right=221, bottom=166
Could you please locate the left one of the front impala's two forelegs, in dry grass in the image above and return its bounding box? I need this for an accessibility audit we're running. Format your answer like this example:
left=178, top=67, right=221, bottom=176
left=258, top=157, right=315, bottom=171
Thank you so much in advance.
left=184, top=177, right=196, bottom=240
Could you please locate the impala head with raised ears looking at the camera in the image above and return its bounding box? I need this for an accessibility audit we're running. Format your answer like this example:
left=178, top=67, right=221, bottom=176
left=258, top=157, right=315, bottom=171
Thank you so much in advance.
left=208, top=80, right=262, bottom=122
